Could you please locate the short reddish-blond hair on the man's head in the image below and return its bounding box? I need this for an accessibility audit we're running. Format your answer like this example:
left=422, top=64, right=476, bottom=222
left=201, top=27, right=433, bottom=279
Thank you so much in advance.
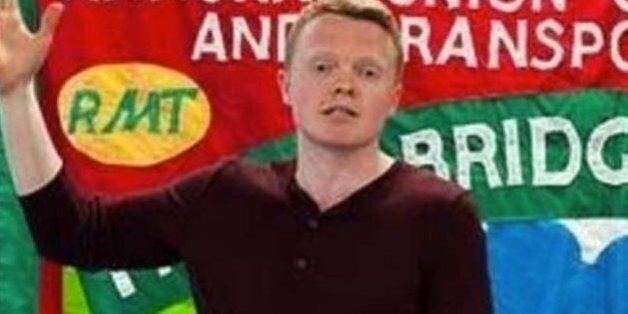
left=285, top=0, right=403, bottom=72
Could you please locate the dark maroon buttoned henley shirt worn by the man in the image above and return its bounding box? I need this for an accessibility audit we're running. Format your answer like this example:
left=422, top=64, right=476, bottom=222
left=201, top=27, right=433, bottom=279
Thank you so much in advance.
left=21, top=159, right=492, bottom=314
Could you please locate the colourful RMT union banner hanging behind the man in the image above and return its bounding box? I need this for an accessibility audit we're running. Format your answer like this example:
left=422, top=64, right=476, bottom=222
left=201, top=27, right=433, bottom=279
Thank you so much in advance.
left=3, top=0, right=628, bottom=314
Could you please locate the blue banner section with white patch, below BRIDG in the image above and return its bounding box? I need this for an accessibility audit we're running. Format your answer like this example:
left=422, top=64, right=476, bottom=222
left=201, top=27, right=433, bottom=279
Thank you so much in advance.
left=487, top=219, right=628, bottom=314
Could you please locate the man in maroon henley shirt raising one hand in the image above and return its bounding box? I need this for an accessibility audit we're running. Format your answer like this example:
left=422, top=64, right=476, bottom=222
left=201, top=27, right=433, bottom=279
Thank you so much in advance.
left=0, top=0, right=491, bottom=314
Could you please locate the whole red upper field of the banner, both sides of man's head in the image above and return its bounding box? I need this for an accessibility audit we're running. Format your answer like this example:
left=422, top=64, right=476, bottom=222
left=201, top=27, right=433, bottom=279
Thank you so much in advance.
left=38, top=0, right=628, bottom=193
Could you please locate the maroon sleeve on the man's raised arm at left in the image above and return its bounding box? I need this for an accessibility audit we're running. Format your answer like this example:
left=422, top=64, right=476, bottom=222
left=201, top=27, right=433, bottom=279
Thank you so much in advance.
left=20, top=163, right=223, bottom=270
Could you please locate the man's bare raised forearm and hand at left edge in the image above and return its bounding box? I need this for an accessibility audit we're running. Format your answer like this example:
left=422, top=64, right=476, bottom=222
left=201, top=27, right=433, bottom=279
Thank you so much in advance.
left=0, top=0, right=63, bottom=195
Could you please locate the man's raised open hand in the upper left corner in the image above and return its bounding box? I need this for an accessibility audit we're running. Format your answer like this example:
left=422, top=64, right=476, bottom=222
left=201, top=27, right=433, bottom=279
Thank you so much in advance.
left=0, top=0, right=63, bottom=95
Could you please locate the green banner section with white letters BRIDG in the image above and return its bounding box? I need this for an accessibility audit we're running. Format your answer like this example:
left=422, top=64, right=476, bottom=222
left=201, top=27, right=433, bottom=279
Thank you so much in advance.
left=382, top=90, right=628, bottom=219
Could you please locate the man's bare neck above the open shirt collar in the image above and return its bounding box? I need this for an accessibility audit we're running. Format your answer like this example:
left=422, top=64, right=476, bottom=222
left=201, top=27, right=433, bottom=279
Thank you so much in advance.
left=295, top=139, right=394, bottom=211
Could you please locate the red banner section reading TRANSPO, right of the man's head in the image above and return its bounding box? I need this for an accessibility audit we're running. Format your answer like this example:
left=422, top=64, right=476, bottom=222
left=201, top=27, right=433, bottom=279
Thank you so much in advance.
left=392, top=0, right=628, bottom=104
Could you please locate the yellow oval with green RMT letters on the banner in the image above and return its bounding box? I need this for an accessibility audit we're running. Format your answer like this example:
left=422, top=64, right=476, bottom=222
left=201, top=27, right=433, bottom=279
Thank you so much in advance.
left=58, top=63, right=211, bottom=167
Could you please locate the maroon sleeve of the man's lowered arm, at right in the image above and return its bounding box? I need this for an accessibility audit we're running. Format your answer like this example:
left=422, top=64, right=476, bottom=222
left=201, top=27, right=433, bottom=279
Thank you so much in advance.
left=426, top=193, right=493, bottom=314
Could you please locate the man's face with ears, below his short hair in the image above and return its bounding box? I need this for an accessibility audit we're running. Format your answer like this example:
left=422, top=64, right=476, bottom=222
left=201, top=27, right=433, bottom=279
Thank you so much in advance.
left=279, top=14, right=401, bottom=149
